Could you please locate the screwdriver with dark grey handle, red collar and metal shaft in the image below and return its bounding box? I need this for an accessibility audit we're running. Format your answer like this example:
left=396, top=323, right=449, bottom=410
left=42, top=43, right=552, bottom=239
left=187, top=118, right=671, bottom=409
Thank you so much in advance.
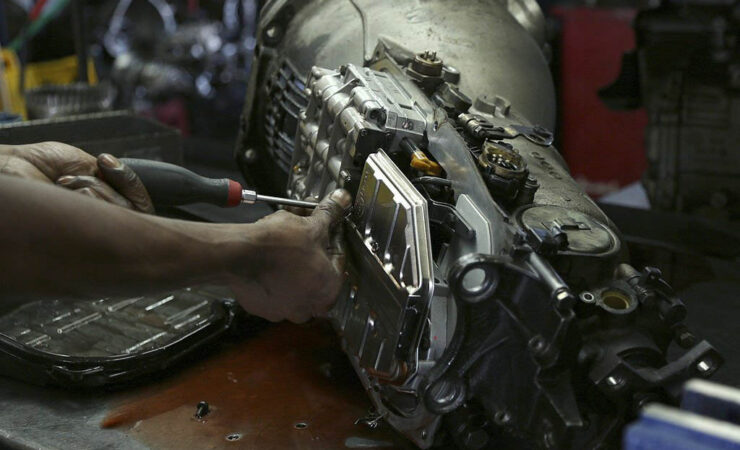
left=121, top=158, right=318, bottom=208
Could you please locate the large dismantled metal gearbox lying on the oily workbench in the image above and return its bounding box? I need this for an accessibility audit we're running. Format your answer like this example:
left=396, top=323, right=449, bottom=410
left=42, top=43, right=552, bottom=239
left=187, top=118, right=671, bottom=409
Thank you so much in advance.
left=236, top=0, right=721, bottom=448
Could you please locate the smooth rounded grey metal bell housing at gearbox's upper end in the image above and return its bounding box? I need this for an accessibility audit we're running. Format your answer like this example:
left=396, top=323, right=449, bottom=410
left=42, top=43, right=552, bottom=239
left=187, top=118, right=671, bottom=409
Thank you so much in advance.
left=235, top=0, right=555, bottom=195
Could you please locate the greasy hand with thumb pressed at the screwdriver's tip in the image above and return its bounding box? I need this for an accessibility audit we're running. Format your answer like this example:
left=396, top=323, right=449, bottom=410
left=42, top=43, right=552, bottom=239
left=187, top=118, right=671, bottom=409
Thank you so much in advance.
left=232, top=189, right=352, bottom=323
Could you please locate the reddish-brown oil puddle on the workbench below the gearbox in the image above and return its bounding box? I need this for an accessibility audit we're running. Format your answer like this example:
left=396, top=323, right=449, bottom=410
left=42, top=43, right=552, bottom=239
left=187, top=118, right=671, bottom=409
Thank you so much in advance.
left=101, top=323, right=410, bottom=449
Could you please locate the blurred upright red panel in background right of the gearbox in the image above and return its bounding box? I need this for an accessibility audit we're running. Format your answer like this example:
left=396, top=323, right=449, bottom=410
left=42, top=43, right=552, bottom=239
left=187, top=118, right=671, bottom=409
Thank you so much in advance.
left=551, top=7, right=647, bottom=197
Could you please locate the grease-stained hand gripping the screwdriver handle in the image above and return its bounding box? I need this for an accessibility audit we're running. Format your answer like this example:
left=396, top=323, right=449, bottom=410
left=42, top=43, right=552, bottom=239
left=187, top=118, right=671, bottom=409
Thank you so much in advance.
left=0, top=142, right=154, bottom=213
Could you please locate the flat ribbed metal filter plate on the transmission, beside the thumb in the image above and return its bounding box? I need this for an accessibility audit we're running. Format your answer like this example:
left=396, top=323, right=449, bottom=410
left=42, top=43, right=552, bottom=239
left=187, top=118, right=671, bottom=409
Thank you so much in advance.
left=334, top=151, right=434, bottom=380
